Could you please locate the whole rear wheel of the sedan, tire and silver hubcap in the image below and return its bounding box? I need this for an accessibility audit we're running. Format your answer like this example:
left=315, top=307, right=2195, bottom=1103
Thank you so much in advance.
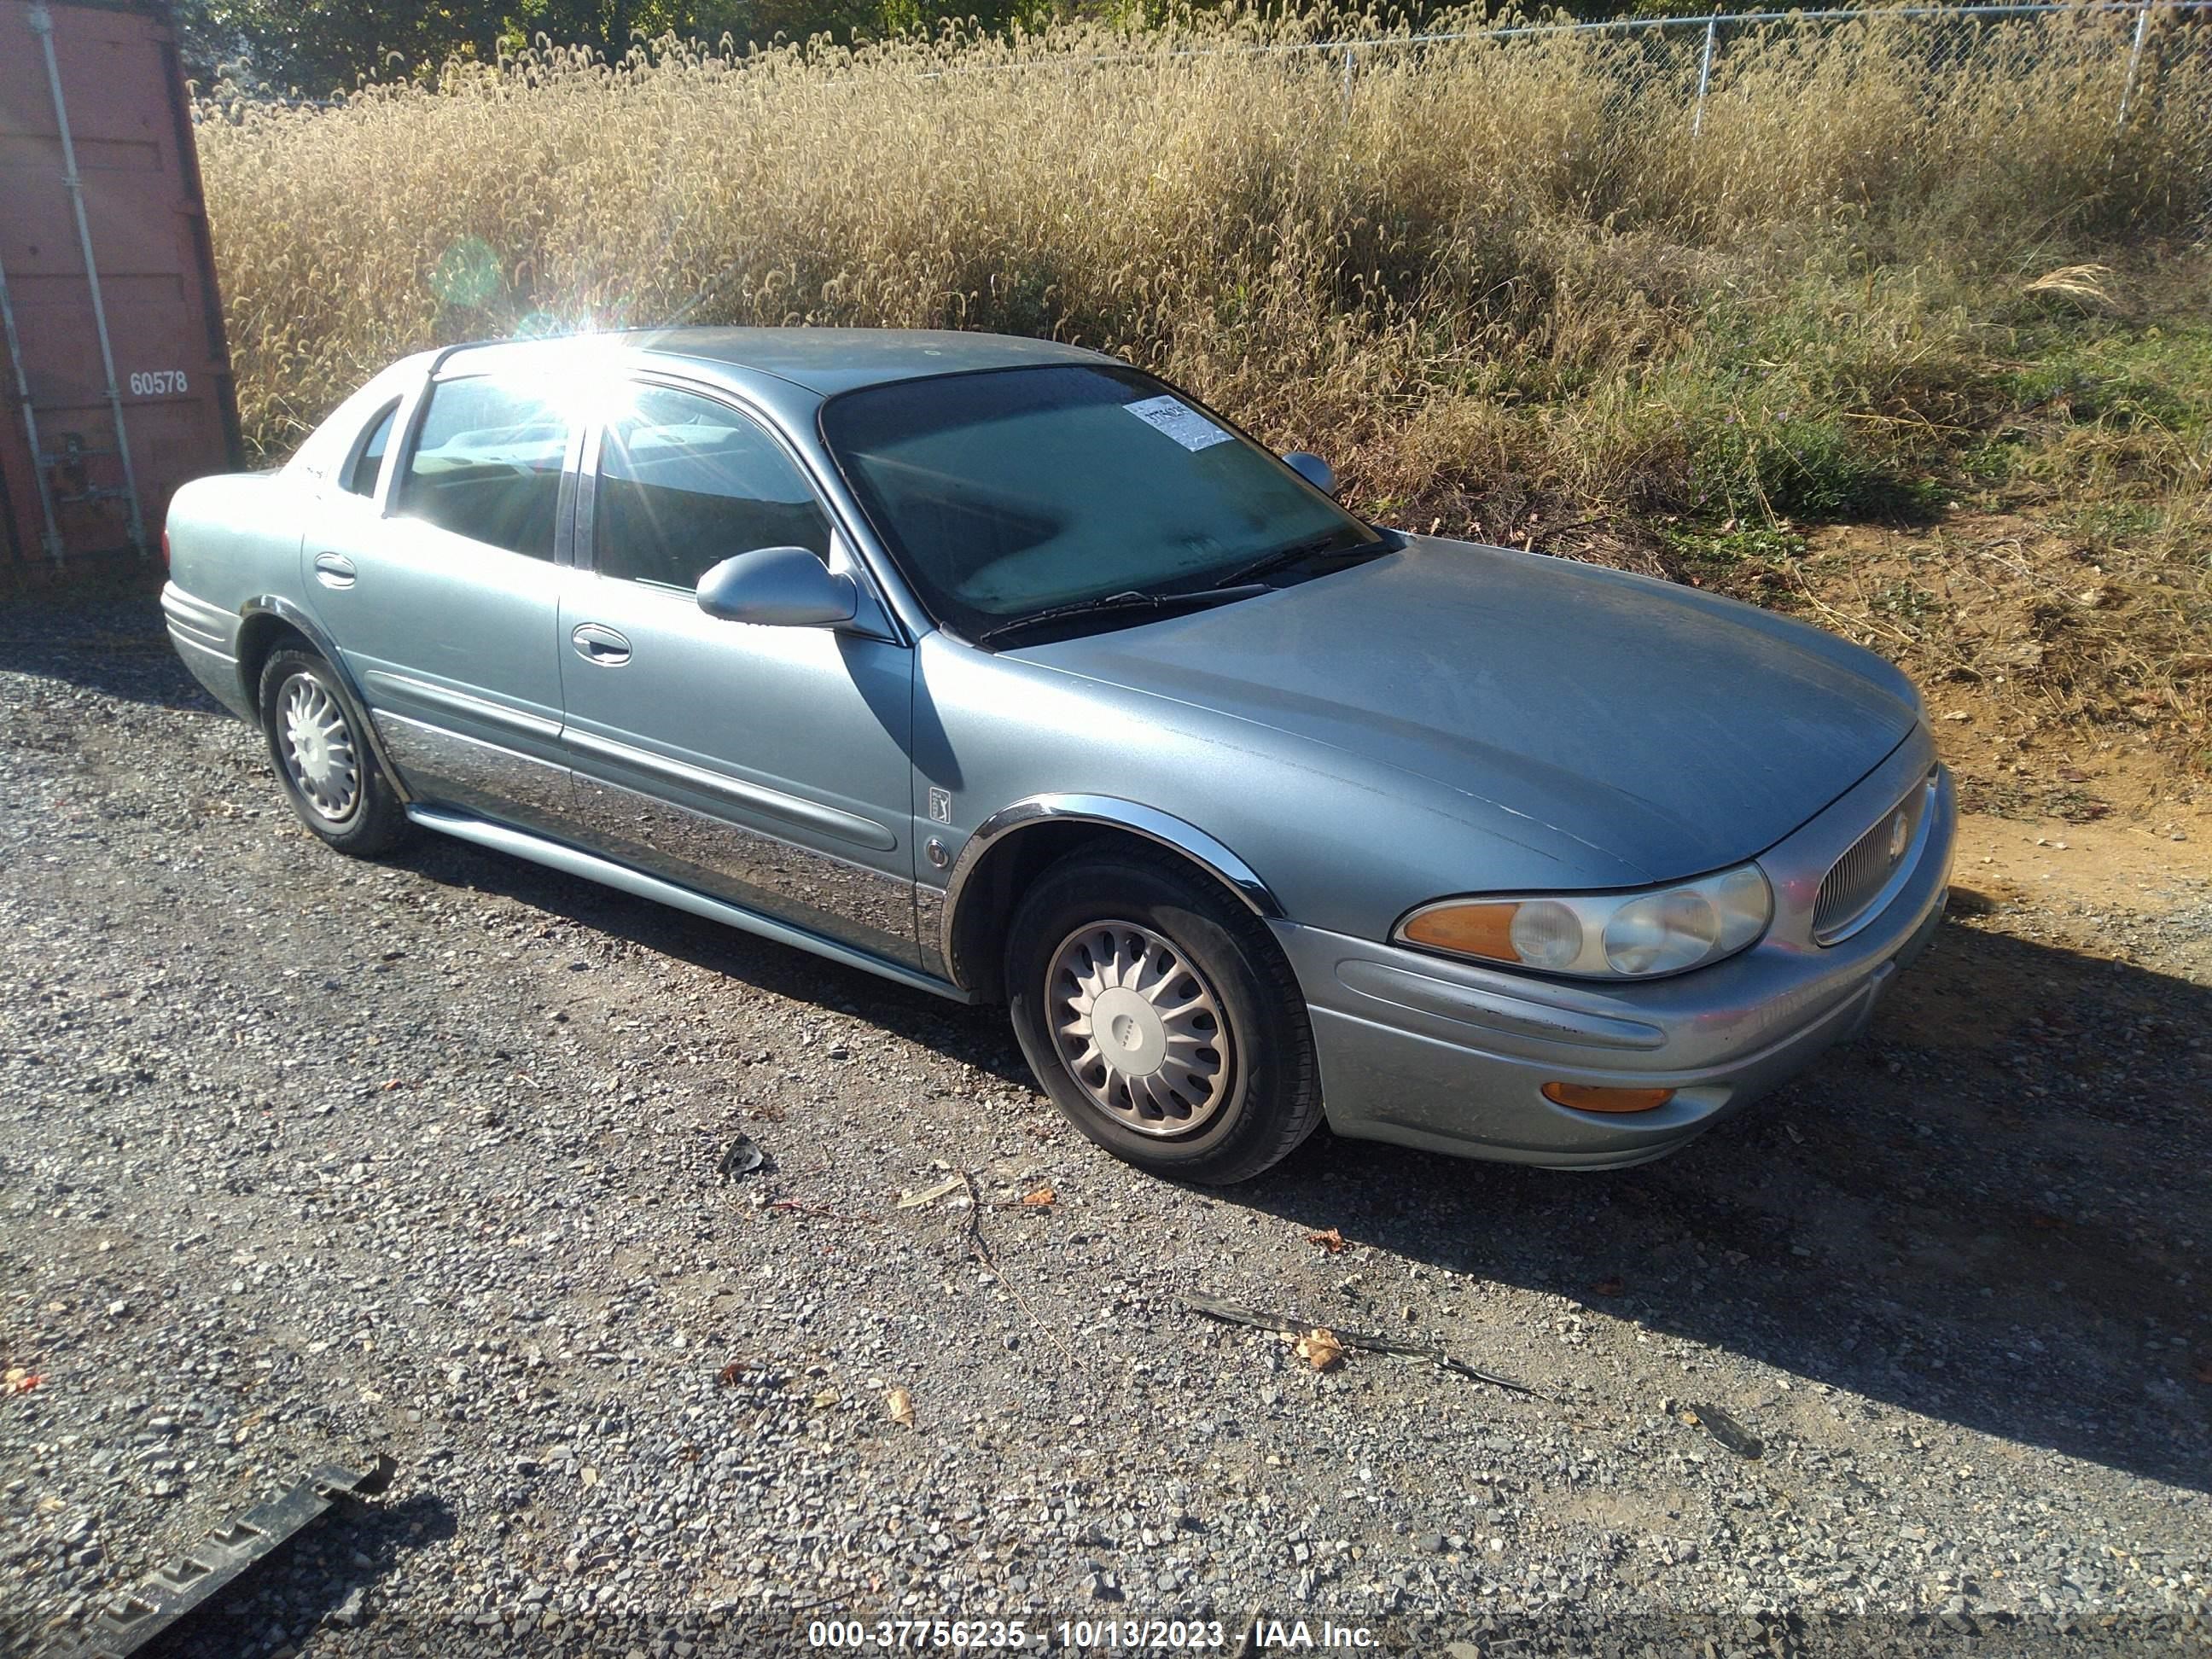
left=261, top=650, right=407, bottom=859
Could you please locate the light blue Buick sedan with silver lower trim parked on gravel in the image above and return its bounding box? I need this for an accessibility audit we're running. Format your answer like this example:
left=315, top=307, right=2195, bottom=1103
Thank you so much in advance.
left=161, top=329, right=1955, bottom=1181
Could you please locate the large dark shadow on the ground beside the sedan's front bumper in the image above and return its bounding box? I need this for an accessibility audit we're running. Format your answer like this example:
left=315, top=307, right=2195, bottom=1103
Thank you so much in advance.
left=1225, top=923, right=2212, bottom=1491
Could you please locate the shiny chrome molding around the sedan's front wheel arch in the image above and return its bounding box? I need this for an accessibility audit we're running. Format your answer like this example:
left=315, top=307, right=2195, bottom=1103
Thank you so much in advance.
left=938, top=795, right=1283, bottom=998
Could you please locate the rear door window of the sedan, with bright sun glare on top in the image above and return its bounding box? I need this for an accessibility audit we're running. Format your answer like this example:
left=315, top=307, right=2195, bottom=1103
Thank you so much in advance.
left=399, top=376, right=568, bottom=560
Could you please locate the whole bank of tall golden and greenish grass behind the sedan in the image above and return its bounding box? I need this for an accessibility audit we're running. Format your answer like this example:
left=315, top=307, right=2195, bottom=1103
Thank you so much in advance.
left=199, top=11, right=2212, bottom=748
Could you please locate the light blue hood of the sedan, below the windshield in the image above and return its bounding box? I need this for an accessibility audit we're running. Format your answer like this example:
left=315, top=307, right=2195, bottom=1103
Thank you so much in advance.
left=1009, top=538, right=1920, bottom=881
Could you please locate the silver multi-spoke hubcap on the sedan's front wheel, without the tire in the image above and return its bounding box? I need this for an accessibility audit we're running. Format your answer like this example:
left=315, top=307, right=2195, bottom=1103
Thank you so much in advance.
left=1044, top=923, right=1237, bottom=1135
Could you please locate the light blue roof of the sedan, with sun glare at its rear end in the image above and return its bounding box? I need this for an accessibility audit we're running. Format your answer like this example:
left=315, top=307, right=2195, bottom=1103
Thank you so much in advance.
left=440, top=328, right=1115, bottom=399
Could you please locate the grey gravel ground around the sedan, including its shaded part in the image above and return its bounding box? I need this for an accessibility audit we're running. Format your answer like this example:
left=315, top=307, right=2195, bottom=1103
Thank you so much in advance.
left=0, top=602, right=2212, bottom=1659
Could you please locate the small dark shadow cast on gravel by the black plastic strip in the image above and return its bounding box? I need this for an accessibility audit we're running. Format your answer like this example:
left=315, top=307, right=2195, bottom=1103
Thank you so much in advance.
left=139, top=1473, right=457, bottom=1659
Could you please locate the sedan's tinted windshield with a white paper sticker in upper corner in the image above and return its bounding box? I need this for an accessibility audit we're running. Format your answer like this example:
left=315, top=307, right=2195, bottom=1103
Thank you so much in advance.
left=823, top=363, right=1376, bottom=637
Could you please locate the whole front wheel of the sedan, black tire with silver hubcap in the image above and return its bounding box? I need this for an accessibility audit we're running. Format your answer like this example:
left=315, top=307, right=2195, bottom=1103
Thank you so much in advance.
left=1006, top=849, right=1320, bottom=1185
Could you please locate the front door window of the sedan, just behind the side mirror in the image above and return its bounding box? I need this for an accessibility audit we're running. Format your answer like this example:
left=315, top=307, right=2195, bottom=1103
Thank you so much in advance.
left=593, top=387, right=830, bottom=593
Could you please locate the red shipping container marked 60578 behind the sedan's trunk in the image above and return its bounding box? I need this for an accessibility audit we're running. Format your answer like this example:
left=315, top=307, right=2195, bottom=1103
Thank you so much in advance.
left=0, top=0, right=239, bottom=591
